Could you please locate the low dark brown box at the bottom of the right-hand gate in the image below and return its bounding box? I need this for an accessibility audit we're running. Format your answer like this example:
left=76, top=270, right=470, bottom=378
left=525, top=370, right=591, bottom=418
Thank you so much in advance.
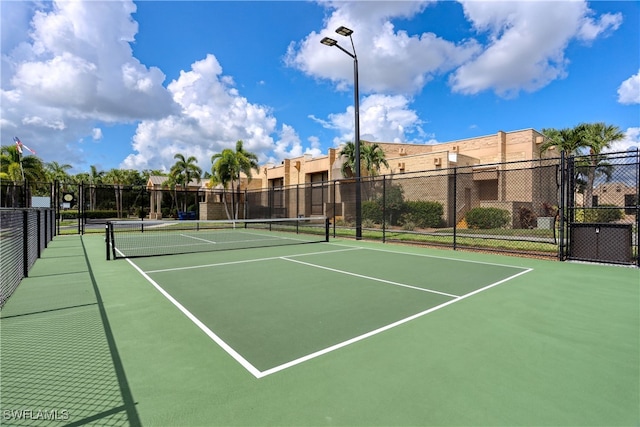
left=569, top=223, right=633, bottom=264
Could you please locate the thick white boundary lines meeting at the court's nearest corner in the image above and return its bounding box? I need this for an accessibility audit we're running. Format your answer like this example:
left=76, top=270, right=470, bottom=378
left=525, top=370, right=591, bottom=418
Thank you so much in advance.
left=127, top=247, right=533, bottom=379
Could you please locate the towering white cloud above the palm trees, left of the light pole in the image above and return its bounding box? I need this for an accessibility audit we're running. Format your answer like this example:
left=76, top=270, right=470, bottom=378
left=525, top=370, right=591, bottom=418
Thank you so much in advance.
left=122, top=55, right=280, bottom=170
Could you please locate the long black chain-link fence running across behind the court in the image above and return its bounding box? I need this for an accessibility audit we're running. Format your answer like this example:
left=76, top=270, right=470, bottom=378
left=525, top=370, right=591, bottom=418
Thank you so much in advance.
left=0, top=151, right=640, bottom=265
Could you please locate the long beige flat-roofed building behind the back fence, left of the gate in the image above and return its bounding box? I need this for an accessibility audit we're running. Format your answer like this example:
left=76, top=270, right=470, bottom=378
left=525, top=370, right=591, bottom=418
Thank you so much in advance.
left=149, top=129, right=558, bottom=227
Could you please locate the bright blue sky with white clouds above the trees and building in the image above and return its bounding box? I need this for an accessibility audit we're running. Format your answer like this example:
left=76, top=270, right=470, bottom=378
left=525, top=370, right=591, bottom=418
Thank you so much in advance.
left=0, top=0, right=640, bottom=173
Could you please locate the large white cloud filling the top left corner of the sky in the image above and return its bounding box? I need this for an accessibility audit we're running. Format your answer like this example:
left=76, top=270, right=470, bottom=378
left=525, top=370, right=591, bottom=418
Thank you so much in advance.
left=0, top=1, right=177, bottom=169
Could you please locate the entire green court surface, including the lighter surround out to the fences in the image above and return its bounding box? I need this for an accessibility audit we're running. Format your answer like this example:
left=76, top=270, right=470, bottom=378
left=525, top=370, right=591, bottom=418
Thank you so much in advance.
left=0, top=235, right=640, bottom=426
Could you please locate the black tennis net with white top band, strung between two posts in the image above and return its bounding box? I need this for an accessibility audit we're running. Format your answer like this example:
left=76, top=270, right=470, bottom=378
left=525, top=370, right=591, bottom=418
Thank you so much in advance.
left=105, top=217, right=329, bottom=259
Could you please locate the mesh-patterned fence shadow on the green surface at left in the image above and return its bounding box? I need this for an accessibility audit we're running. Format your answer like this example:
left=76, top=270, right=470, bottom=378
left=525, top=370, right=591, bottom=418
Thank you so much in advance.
left=0, top=236, right=140, bottom=426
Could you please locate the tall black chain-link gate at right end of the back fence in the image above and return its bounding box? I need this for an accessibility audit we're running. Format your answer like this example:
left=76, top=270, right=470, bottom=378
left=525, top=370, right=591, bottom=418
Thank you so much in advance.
left=560, top=151, right=640, bottom=266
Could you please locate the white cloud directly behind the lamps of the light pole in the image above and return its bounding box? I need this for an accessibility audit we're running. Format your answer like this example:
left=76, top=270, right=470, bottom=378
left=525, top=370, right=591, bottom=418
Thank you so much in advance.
left=285, top=1, right=478, bottom=94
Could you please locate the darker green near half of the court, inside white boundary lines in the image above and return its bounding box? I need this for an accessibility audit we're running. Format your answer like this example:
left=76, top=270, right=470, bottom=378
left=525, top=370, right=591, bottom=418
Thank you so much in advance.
left=125, top=243, right=529, bottom=378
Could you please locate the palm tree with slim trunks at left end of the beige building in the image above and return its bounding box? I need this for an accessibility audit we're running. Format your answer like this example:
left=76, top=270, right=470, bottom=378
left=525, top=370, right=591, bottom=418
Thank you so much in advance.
left=211, top=140, right=259, bottom=219
